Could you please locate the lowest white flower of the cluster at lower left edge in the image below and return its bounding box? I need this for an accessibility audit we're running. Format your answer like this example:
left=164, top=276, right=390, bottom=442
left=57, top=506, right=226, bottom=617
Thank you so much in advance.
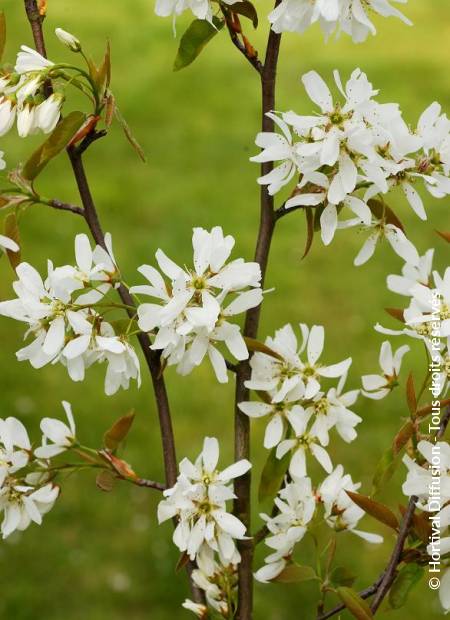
left=0, top=484, right=59, bottom=538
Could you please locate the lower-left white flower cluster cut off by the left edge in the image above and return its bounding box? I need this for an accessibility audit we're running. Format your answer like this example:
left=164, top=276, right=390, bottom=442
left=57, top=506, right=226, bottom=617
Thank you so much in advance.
left=0, top=402, right=76, bottom=538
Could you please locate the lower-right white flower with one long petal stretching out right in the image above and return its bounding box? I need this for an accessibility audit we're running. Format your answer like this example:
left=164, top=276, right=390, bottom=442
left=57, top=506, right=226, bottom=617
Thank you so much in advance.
left=317, top=465, right=383, bottom=543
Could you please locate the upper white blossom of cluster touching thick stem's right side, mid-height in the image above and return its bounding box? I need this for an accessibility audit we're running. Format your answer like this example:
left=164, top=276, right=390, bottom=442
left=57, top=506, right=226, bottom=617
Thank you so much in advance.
left=245, top=323, right=351, bottom=403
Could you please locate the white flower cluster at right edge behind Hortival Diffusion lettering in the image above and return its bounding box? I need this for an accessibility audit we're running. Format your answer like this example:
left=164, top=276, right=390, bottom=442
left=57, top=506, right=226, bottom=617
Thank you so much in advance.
left=403, top=440, right=450, bottom=613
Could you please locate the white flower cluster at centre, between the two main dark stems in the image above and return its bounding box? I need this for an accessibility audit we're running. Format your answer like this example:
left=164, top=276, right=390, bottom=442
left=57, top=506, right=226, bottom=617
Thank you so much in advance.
left=130, top=226, right=262, bottom=383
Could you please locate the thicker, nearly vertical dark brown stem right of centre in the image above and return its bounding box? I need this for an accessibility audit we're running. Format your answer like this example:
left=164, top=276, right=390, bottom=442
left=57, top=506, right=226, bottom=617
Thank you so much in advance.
left=234, top=8, right=281, bottom=620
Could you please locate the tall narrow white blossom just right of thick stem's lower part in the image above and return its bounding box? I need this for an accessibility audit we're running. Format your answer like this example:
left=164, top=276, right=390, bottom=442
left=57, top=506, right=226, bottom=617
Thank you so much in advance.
left=255, top=478, right=316, bottom=583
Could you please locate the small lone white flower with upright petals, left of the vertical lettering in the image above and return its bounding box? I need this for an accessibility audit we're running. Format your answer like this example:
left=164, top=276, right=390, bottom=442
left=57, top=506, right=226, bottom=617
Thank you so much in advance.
left=361, top=340, right=410, bottom=400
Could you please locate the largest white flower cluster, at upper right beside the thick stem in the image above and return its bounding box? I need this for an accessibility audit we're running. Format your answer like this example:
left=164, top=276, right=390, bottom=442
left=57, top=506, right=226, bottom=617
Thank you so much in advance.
left=251, top=69, right=450, bottom=265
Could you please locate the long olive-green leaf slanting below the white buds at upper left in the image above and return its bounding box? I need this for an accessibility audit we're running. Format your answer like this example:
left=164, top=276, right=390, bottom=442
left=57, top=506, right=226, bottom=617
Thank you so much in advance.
left=22, top=112, right=86, bottom=181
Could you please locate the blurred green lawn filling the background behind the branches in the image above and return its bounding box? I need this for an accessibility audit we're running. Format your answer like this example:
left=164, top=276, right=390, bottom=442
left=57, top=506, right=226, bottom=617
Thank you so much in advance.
left=0, top=0, right=450, bottom=620
